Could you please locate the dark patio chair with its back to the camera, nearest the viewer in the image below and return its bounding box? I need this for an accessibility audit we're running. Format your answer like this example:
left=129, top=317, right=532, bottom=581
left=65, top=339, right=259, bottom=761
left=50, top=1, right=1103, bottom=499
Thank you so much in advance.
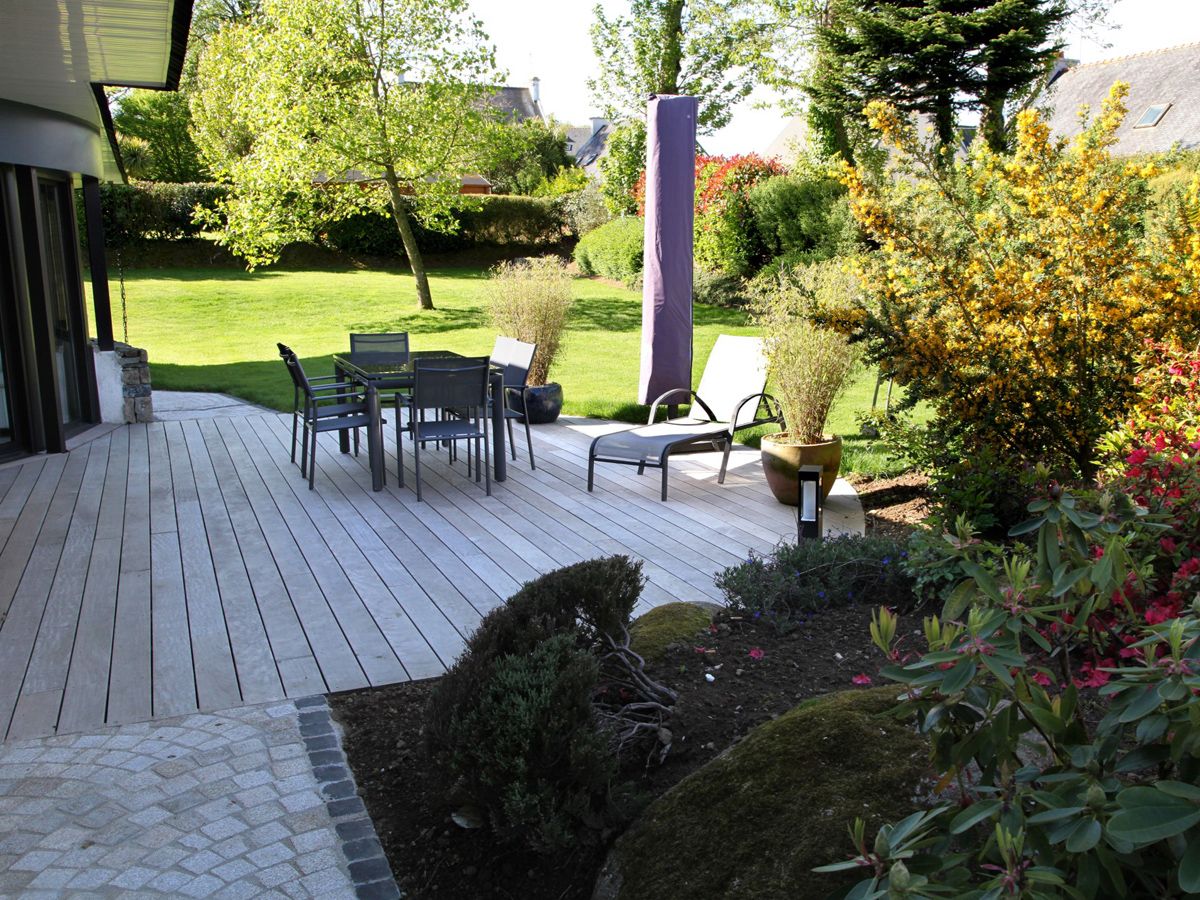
left=396, top=356, right=492, bottom=500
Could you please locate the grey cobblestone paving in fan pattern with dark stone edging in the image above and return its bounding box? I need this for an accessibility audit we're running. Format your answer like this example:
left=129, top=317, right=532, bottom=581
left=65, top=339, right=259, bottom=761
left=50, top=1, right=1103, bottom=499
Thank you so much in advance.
left=0, top=697, right=388, bottom=900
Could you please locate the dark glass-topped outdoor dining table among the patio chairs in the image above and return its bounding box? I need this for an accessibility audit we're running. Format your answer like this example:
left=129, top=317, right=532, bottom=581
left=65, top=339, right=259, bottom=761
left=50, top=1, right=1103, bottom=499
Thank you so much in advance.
left=334, top=350, right=509, bottom=491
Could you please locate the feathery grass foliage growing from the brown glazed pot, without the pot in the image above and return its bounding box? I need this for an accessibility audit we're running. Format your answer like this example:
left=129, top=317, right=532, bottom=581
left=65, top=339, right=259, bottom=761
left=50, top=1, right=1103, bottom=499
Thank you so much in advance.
left=751, top=262, right=860, bottom=444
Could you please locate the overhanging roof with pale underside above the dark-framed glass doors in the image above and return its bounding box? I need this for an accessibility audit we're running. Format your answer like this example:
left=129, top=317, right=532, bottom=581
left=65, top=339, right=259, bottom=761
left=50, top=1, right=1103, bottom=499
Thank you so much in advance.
left=0, top=0, right=192, bottom=180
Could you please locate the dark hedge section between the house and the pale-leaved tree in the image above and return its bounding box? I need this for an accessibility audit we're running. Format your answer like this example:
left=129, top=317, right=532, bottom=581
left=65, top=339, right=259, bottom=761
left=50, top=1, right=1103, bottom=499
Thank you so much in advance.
left=76, top=182, right=229, bottom=247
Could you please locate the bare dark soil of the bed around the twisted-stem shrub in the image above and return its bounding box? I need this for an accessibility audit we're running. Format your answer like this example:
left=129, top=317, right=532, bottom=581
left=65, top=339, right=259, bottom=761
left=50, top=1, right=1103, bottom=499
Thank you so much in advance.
left=330, top=606, right=881, bottom=900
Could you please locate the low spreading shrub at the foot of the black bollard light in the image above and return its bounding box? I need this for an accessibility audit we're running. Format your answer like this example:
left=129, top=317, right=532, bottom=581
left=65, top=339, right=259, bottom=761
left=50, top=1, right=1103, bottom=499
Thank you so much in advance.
left=716, top=535, right=913, bottom=618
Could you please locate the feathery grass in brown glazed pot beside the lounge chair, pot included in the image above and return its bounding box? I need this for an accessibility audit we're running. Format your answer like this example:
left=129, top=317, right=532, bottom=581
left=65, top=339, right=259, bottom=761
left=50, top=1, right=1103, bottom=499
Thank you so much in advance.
left=752, top=260, right=859, bottom=505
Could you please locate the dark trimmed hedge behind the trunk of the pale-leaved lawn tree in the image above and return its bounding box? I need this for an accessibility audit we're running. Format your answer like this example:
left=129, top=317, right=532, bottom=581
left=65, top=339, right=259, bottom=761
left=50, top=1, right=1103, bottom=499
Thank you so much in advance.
left=323, top=194, right=568, bottom=256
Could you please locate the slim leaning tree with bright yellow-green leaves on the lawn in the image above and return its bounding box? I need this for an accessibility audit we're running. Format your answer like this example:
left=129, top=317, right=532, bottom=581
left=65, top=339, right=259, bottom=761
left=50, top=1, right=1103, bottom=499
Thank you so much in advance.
left=192, top=0, right=497, bottom=310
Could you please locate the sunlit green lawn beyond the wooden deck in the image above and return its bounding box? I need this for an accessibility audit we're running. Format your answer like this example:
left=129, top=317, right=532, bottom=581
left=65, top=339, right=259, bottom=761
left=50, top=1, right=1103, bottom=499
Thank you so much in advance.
left=84, top=269, right=907, bottom=473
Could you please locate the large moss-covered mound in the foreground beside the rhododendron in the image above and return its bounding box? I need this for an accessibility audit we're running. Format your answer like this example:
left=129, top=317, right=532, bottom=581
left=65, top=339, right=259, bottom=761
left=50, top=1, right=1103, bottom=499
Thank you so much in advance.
left=596, top=688, right=929, bottom=900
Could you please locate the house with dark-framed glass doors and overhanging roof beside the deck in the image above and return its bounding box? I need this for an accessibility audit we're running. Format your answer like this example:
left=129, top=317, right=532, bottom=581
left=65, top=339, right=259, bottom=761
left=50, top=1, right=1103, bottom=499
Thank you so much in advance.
left=0, top=0, right=192, bottom=456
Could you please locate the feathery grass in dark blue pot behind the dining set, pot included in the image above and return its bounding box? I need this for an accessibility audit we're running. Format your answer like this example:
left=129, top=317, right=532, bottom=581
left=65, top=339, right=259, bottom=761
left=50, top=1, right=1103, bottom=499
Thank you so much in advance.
left=486, top=257, right=572, bottom=425
